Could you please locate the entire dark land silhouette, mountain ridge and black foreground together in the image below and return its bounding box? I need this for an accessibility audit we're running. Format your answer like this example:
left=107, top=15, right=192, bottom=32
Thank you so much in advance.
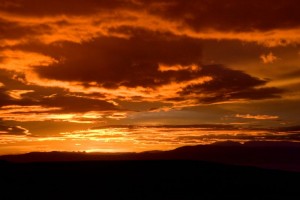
left=0, top=141, right=300, bottom=200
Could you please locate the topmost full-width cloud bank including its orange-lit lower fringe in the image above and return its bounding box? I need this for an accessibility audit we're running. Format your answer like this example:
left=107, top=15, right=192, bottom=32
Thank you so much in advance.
left=0, top=0, right=300, bottom=46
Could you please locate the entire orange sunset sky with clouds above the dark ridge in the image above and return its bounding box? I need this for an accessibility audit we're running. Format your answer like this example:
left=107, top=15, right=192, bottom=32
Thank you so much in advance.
left=0, top=0, right=300, bottom=154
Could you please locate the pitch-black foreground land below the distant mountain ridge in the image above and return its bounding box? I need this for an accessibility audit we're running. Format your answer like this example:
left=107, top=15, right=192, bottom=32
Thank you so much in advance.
left=0, top=160, right=300, bottom=200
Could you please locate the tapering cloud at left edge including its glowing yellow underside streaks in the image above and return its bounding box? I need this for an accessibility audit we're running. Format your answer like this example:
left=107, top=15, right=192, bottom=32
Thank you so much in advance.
left=0, top=76, right=122, bottom=123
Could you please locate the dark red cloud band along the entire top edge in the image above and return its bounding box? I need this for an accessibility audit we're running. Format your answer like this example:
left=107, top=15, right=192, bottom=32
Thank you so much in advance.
left=0, top=0, right=300, bottom=31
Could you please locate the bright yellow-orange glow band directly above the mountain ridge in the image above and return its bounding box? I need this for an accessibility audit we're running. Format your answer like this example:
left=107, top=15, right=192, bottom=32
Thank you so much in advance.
left=0, top=126, right=300, bottom=155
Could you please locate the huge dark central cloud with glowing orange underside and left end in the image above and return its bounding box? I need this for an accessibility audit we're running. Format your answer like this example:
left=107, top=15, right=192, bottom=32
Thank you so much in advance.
left=0, top=30, right=283, bottom=108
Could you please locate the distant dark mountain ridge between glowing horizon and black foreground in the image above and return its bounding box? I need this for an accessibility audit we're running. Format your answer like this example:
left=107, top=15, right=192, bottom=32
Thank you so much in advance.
left=0, top=141, right=300, bottom=172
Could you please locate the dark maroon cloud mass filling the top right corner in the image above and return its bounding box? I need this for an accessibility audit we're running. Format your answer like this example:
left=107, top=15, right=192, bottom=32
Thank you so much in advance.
left=146, top=0, right=300, bottom=31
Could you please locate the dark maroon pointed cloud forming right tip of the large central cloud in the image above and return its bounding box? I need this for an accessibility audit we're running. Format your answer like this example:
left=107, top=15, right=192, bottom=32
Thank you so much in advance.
left=179, top=65, right=283, bottom=103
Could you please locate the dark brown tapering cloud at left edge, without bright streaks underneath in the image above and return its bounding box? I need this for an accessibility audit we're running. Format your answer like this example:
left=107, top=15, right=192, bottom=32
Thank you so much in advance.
left=0, top=74, right=119, bottom=113
